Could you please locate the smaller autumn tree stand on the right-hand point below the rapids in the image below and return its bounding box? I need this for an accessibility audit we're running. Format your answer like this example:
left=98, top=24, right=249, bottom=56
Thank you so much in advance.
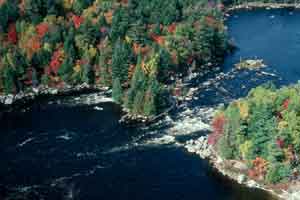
left=209, top=83, right=300, bottom=184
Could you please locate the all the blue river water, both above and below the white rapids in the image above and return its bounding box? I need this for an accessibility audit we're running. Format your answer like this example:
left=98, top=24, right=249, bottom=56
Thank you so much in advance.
left=0, top=11, right=300, bottom=200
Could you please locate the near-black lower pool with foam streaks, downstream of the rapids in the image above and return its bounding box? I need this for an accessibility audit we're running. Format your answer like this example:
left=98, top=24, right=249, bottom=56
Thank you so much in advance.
left=0, top=103, right=272, bottom=200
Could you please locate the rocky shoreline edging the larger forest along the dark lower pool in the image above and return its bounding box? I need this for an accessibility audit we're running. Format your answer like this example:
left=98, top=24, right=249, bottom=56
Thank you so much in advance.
left=0, top=83, right=176, bottom=126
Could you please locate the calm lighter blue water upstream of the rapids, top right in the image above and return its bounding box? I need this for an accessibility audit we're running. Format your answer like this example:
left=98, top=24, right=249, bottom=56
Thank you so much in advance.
left=225, top=9, right=300, bottom=83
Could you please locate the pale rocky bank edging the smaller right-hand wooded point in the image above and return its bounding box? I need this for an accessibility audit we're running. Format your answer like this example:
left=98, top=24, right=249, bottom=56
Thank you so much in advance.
left=184, top=136, right=300, bottom=200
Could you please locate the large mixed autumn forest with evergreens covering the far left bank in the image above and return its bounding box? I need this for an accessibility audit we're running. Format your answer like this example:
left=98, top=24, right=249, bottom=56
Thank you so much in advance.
left=0, top=0, right=228, bottom=115
